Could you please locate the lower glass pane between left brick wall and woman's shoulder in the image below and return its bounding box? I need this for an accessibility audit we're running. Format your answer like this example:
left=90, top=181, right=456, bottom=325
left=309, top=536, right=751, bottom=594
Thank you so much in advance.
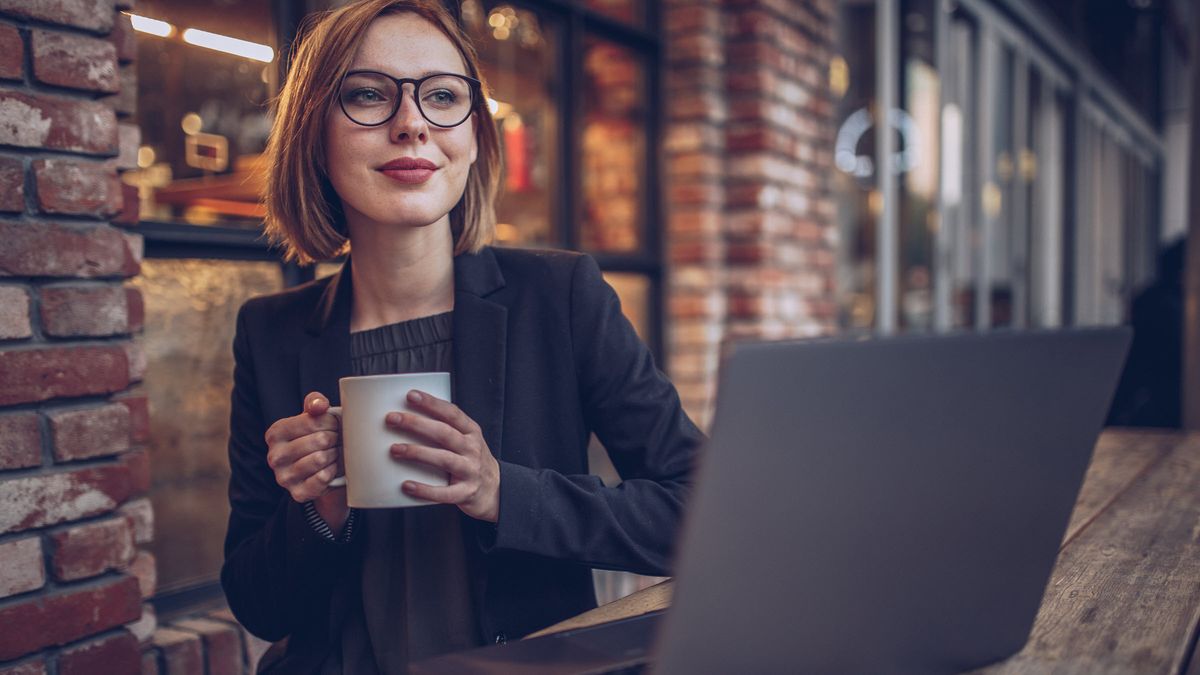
left=131, top=259, right=283, bottom=593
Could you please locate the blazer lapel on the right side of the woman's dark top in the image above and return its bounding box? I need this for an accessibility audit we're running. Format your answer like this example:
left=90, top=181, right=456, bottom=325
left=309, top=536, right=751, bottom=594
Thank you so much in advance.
left=454, top=249, right=508, bottom=459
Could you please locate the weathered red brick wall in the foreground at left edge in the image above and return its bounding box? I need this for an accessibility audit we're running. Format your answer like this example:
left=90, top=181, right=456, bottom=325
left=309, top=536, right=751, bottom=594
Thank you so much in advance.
left=0, top=0, right=154, bottom=675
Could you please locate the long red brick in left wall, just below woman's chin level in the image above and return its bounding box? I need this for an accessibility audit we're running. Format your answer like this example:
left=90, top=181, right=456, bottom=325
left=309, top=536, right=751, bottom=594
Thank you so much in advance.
left=0, top=221, right=137, bottom=277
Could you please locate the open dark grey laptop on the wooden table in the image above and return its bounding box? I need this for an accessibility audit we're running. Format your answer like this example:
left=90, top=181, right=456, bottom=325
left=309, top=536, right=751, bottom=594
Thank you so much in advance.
left=412, top=328, right=1132, bottom=674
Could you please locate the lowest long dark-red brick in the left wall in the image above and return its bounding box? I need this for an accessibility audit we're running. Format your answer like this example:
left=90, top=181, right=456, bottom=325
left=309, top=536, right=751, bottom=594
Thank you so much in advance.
left=0, top=569, right=142, bottom=659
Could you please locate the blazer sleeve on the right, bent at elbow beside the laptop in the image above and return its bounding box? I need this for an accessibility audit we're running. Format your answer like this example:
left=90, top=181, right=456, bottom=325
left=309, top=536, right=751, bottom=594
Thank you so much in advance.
left=496, top=256, right=704, bottom=575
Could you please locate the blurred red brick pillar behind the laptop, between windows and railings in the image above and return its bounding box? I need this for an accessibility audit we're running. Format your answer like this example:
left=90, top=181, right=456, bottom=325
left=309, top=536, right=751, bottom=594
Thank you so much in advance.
left=664, top=0, right=836, bottom=426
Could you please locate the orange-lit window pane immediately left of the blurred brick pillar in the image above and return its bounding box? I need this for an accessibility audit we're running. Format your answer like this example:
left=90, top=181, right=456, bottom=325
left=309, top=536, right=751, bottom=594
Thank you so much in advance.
left=581, top=37, right=647, bottom=252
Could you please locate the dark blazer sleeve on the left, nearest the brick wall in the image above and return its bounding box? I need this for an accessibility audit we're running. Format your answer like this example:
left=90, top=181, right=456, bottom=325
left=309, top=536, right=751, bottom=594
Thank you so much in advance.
left=221, top=305, right=361, bottom=640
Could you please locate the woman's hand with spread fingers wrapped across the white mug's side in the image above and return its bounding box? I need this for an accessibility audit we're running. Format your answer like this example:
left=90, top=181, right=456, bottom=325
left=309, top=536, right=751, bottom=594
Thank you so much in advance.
left=385, top=390, right=500, bottom=522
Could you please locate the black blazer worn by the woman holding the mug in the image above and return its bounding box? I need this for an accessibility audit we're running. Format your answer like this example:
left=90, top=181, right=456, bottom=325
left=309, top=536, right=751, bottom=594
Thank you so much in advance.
left=221, top=249, right=703, bottom=671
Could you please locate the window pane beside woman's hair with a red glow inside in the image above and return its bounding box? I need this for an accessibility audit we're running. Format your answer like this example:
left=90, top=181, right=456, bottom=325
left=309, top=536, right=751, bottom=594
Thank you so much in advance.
left=462, top=0, right=559, bottom=245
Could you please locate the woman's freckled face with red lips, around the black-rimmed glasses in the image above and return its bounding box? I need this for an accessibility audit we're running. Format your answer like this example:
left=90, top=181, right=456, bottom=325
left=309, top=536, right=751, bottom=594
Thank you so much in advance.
left=325, top=12, right=478, bottom=237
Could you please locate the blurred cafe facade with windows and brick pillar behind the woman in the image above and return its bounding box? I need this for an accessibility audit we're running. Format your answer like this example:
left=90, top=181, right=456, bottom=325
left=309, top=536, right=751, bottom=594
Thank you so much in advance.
left=110, top=0, right=1196, bottom=634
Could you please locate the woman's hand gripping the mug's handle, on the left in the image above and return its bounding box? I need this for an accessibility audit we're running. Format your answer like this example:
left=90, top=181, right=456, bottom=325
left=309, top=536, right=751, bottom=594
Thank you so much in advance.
left=265, top=392, right=350, bottom=533
